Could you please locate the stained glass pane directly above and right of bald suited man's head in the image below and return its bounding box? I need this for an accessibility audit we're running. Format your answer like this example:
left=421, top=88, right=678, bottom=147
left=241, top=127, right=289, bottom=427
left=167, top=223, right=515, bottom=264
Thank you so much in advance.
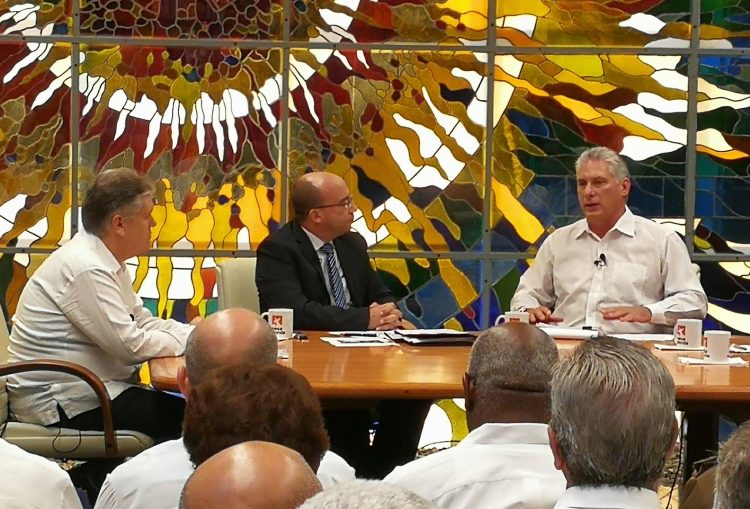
left=289, top=50, right=487, bottom=251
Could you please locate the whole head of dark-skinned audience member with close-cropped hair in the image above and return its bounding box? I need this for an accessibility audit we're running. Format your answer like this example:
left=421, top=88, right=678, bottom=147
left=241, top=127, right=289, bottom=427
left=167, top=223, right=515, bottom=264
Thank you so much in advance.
left=464, top=323, right=558, bottom=430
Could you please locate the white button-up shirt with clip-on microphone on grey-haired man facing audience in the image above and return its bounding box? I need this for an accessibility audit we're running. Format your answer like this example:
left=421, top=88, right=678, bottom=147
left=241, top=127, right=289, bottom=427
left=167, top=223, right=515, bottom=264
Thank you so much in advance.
left=510, top=208, right=708, bottom=333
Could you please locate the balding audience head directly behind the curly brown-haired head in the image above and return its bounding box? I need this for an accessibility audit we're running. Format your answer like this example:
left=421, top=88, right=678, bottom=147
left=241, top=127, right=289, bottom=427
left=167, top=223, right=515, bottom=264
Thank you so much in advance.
left=177, top=308, right=278, bottom=398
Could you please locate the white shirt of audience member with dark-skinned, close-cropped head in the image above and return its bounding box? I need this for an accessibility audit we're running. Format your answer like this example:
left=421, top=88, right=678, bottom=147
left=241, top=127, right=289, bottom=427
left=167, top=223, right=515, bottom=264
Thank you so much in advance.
left=384, top=423, right=565, bottom=509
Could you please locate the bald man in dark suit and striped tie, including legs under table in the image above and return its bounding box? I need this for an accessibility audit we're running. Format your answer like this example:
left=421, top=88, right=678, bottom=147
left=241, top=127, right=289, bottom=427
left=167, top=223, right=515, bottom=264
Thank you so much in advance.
left=255, top=172, right=430, bottom=478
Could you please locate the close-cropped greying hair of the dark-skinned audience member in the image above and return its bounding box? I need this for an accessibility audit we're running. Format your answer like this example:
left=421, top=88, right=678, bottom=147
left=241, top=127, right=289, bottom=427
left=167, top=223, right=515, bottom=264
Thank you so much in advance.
left=468, top=323, right=558, bottom=403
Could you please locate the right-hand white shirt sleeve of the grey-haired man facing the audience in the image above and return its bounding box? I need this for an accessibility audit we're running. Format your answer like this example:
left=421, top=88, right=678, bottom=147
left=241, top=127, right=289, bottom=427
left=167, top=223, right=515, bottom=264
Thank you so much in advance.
left=645, top=232, right=708, bottom=325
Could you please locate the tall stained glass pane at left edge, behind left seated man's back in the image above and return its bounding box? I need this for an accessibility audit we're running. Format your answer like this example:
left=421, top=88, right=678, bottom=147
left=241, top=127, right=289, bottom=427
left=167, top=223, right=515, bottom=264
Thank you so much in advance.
left=0, top=43, right=71, bottom=248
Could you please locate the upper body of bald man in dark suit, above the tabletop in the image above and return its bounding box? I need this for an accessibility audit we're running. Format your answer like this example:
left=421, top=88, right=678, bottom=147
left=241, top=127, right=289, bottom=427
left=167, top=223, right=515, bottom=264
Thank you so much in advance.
left=255, top=172, right=401, bottom=330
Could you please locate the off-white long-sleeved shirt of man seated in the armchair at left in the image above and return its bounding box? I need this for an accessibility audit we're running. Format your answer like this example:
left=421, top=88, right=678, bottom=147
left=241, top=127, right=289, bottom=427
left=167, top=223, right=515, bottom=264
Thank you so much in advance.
left=8, top=231, right=192, bottom=425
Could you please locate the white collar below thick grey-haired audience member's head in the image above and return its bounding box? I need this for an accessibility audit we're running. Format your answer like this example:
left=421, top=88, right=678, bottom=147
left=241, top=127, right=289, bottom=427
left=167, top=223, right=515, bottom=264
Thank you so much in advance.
left=555, top=486, right=661, bottom=509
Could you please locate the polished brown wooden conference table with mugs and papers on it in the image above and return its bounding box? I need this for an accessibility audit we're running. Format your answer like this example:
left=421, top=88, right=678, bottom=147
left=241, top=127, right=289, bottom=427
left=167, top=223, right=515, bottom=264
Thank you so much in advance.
left=149, top=332, right=750, bottom=478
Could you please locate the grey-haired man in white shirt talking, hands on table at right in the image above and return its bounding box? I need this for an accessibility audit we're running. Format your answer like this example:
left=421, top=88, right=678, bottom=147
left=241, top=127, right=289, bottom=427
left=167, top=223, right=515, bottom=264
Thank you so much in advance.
left=510, top=147, right=707, bottom=333
